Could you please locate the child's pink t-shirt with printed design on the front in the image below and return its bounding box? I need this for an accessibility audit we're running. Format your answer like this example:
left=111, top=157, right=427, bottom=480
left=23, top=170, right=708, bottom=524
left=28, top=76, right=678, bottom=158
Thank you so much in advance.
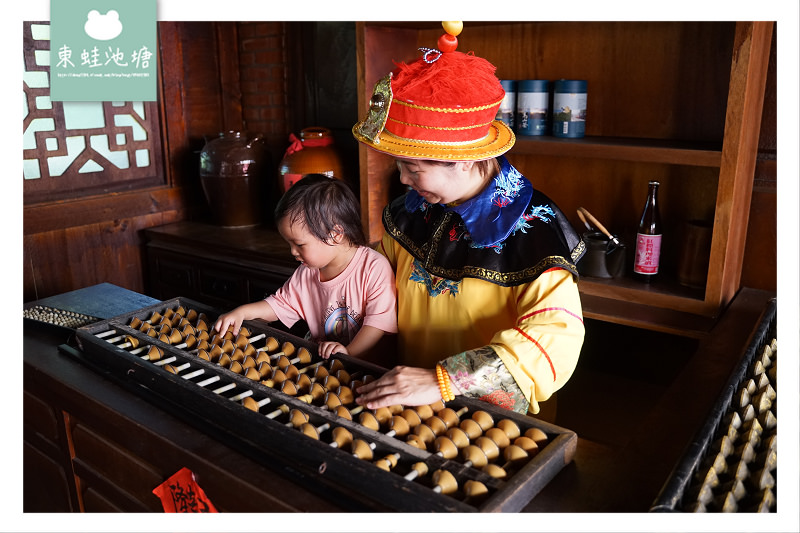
left=265, top=246, right=397, bottom=345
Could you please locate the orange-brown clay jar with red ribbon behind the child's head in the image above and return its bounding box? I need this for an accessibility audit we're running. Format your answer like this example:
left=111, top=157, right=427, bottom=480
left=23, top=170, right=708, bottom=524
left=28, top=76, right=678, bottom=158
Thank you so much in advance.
left=278, top=127, right=345, bottom=194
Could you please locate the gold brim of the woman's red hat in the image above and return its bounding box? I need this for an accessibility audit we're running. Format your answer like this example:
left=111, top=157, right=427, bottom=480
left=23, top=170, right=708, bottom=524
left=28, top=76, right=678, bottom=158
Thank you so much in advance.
left=353, top=120, right=516, bottom=161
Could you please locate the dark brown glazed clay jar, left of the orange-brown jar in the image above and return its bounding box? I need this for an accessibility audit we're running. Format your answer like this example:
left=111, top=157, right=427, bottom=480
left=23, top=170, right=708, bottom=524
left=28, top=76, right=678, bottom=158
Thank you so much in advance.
left=200, top=131, right=272, bottom=227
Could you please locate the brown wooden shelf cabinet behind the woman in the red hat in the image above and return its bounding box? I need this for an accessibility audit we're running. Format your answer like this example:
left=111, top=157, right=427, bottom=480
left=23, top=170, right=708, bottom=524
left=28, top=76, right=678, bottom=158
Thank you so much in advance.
left=356, top=22, right=773, bottom=336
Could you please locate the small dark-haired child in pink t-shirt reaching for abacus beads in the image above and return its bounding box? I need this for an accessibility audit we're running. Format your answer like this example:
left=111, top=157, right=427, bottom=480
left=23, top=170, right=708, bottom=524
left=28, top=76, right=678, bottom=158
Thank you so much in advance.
left=214, top=174, right=397, bottom=359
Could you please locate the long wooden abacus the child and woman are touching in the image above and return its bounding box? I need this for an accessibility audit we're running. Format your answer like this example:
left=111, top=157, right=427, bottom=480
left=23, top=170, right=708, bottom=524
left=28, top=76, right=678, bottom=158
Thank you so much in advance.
left=77, top=298, right=577, bottom=512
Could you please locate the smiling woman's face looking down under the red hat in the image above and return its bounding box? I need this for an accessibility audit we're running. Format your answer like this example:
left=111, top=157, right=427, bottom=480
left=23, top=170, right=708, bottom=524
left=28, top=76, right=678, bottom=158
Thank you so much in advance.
left=396, top=159, right=483, bottom=204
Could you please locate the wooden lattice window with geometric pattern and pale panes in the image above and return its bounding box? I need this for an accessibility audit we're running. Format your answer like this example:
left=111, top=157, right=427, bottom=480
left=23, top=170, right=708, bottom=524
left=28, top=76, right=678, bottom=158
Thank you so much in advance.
left=22, top=22, right=165, bottom=204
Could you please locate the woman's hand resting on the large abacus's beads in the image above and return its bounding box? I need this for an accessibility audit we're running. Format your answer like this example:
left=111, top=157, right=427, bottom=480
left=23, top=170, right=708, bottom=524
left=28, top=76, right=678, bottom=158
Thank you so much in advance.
left=356, top=366, right=442, bottom=409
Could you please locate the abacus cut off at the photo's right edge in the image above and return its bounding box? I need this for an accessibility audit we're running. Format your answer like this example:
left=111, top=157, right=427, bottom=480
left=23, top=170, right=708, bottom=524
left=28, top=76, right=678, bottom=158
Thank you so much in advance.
left=651, top=300, right=778, bottom=513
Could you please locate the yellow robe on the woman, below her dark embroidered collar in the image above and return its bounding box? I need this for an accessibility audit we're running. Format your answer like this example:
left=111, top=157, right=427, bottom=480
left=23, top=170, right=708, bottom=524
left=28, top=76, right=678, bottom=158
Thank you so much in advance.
left=378, top=234, right=584, bottom=414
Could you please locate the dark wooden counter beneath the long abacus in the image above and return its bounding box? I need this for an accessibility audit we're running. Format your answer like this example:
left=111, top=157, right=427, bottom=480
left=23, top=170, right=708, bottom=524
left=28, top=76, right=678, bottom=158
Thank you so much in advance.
left=23, top=282, right=774, bottom=512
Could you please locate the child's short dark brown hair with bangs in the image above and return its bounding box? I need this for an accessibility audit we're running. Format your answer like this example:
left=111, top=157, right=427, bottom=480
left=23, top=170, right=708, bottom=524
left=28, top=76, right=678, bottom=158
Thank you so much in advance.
left=275, top=174, right=367, bottom=246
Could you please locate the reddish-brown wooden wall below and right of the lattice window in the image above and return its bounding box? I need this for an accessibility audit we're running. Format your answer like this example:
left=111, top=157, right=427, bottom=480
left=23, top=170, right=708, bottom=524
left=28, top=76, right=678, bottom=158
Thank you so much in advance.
left=23, top=22, right=250, bottom=301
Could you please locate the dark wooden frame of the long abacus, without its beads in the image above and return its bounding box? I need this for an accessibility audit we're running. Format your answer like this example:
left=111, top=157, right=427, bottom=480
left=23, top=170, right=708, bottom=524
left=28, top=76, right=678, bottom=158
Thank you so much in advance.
left=77, top=298, right=577, bottom=512
